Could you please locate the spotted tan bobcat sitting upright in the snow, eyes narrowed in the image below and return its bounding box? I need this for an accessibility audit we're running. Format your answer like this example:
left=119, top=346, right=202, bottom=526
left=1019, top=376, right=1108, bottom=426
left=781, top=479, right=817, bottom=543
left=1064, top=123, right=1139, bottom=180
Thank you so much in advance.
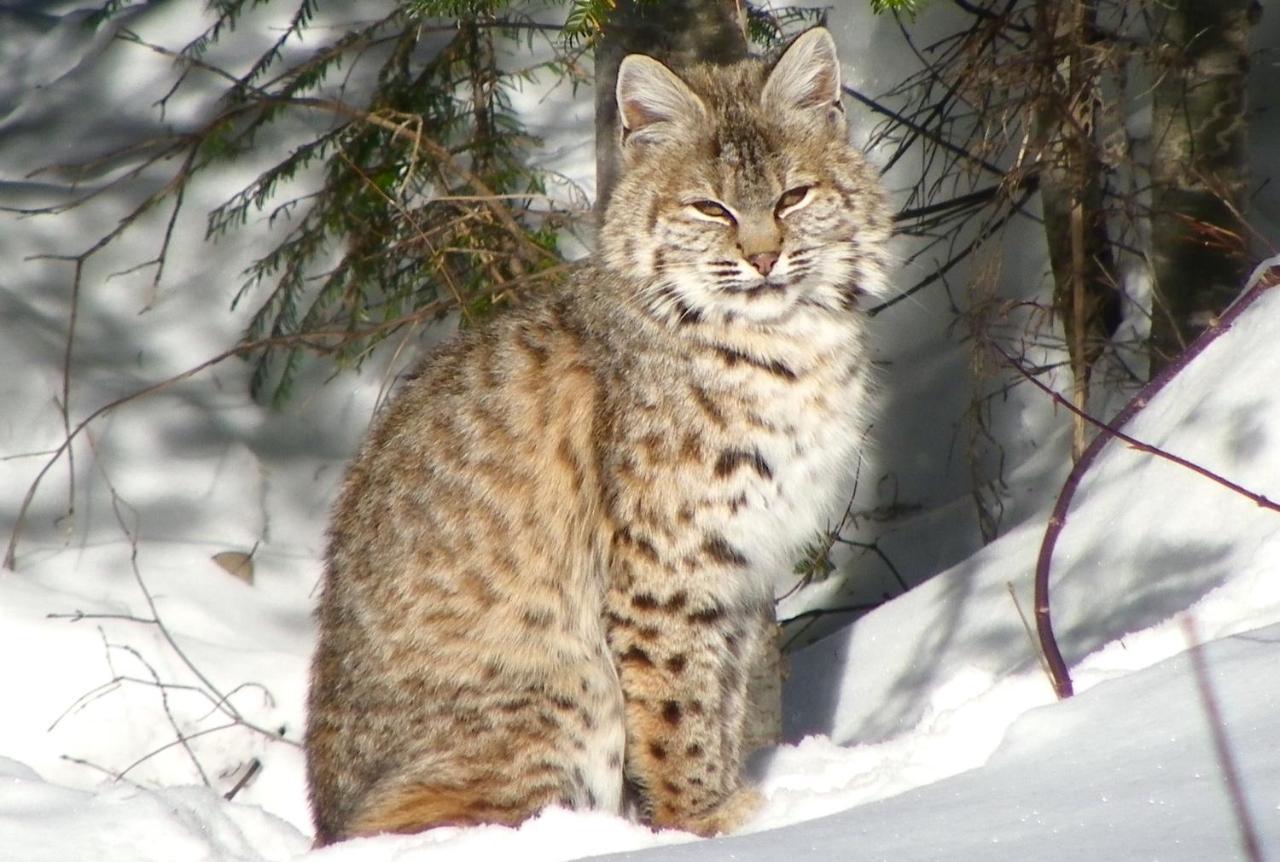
left=306, top=28, right=890, bottom=844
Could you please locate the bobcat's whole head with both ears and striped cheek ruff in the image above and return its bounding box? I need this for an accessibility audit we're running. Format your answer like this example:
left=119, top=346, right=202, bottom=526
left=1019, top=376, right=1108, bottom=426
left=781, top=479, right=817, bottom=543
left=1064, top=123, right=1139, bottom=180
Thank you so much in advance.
left=602, top=32, right=887, bottom=323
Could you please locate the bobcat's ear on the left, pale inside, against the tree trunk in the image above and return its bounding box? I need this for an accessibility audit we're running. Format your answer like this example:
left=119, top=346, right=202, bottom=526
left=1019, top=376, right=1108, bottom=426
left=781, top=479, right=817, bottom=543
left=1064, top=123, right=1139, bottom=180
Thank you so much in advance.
left=617, top=54, right=707, bottom=147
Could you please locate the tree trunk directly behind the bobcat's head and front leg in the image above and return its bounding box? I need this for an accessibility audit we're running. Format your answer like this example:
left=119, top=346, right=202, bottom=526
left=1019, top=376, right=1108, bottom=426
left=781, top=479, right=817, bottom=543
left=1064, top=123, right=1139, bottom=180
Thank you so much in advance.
left=595, top=0, right=782, bottom=751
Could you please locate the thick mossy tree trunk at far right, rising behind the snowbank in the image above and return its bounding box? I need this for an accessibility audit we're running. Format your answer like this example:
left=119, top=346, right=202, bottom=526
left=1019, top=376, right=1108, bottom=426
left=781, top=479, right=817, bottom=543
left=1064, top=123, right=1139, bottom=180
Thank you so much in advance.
left=1149, top=0, right=1261, bottom=374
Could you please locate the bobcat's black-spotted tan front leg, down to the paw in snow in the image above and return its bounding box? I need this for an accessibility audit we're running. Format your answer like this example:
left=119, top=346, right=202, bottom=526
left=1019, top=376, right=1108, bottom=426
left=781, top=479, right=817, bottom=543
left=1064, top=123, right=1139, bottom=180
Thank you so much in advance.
left=607, top=530, right=762, bottom=835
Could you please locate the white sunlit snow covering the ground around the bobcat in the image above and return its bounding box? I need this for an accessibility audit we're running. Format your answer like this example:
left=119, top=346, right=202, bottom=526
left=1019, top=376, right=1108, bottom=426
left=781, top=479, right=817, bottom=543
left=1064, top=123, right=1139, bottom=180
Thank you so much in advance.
left=0, top=4, right=1280, bottom=862
